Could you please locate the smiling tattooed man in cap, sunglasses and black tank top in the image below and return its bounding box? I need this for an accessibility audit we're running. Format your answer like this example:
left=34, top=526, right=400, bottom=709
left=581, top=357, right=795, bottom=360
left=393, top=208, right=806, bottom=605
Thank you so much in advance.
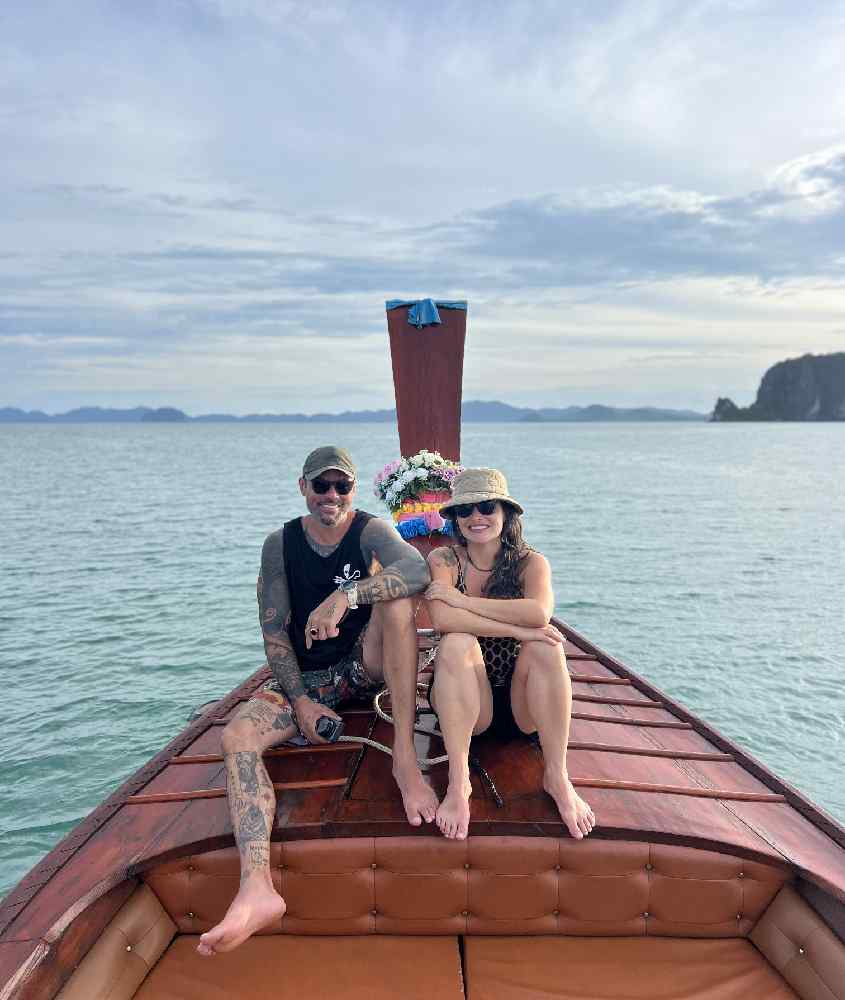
left=197, top=447, right=437, bottom=955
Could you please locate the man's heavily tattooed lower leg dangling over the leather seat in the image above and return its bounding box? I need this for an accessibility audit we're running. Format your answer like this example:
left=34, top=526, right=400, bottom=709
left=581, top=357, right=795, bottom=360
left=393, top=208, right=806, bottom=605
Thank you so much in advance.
left=197, top=692, right=296, bottom=955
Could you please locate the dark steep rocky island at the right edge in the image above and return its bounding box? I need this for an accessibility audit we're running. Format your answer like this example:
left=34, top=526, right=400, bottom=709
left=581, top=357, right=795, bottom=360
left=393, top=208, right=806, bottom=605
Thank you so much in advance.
left=710, top=351, right=845, bottom=423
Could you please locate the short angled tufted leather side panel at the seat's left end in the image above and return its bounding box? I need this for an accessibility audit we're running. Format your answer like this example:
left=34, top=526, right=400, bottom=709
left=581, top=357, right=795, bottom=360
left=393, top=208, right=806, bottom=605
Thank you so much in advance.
left=57, top=885, right=176, bottom=1000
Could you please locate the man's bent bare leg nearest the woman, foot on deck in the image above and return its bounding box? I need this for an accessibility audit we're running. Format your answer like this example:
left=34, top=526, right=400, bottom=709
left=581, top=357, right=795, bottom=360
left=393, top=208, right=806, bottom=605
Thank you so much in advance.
left=364, top=596, right=437, bottom=826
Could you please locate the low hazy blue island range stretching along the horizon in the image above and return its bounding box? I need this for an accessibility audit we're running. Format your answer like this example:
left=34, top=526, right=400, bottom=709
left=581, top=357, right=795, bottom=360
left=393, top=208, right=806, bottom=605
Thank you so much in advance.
left=0, top=400, right=707, bottom=424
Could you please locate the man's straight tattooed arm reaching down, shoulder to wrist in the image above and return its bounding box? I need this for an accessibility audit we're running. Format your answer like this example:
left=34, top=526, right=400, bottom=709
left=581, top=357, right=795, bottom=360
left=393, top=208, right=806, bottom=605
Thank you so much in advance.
left=258, top=530, right=305, bottom=704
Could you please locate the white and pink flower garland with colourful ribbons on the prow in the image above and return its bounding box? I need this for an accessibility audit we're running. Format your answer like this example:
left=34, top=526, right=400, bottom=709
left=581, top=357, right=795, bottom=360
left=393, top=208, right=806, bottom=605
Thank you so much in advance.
left=373, top=448, right=463, bottom=538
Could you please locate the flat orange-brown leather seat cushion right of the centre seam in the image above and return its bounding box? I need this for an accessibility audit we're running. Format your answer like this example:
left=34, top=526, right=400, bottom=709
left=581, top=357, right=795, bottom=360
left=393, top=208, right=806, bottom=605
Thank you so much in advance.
left=464, top=937, right=798, bottom=1000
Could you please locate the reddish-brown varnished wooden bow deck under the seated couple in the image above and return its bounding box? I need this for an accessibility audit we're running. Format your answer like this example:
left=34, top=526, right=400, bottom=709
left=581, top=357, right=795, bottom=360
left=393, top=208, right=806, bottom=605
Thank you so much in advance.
left=0, top=622, right=845, bottom=983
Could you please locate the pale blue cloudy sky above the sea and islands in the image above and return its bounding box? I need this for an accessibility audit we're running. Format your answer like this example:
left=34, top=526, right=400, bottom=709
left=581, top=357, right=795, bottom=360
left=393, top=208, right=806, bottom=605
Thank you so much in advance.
left=0, top=0, right=845, bottom=415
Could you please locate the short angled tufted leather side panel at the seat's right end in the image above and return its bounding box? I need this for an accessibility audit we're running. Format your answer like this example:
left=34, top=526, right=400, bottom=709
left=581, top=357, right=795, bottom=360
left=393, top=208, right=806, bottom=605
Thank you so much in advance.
left=751, top=886, right=845, bottom=1000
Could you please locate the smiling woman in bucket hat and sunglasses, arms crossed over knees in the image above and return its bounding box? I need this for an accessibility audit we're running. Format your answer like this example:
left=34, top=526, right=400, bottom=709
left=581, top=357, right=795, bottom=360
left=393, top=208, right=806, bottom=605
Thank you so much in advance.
left=426, top=469, right=596, bottom=840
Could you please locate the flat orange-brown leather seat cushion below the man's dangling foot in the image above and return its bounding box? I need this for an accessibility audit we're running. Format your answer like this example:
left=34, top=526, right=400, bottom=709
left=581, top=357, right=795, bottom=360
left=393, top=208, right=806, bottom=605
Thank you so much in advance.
left=136, top=934, right=464, bottom=1000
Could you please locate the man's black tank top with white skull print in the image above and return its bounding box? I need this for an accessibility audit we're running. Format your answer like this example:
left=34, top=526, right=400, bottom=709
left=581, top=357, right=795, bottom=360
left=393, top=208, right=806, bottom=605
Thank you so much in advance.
left=282, top=510, right=373, bottom=670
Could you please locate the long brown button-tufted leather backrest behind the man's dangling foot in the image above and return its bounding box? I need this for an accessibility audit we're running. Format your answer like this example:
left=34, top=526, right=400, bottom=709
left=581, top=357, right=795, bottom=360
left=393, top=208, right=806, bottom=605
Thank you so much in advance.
left=145, top=837, right=786, bottom=938
